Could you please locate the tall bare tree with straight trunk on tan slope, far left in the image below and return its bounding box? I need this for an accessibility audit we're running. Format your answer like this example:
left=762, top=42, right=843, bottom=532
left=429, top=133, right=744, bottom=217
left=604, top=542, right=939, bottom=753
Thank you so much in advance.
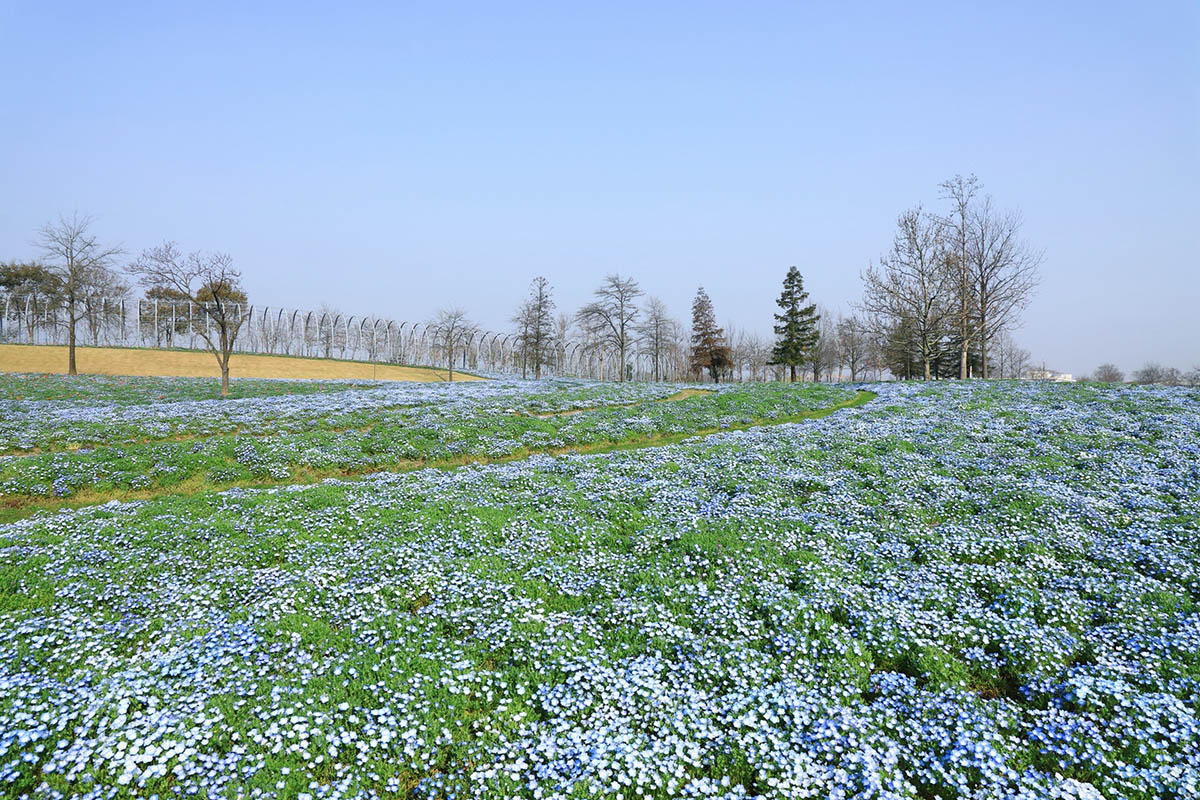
left=36, top=213, right=122, bottom=375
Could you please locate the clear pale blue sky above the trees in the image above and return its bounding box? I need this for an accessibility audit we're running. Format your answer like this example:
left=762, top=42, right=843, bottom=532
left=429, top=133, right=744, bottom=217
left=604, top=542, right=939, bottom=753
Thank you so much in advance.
left=0, top=0, right=1200, bottom=373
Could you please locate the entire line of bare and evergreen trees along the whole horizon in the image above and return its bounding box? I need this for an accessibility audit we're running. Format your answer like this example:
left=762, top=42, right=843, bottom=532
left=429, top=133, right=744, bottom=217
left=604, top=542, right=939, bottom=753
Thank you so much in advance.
left=7, top=185, right=1200, bottom=392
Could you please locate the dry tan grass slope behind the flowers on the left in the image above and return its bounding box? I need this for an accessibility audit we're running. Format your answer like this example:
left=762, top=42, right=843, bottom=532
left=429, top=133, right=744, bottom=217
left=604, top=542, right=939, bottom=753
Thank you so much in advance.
left=0, top=344, right=482, bottom=381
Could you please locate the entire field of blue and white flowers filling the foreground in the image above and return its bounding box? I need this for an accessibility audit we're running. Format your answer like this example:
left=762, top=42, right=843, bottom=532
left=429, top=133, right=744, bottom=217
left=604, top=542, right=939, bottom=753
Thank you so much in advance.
left=0, top=377, right=1200, bottom=800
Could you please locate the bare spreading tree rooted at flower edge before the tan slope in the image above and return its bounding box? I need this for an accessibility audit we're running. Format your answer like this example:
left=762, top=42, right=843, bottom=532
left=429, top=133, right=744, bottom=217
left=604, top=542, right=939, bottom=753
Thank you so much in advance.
left=130, top=241, right=246, bottom=397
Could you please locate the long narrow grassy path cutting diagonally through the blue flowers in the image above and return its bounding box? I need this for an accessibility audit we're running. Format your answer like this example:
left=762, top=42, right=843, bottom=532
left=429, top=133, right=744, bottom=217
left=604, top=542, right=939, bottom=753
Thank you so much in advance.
left=0, top=390, right=876, bottom=523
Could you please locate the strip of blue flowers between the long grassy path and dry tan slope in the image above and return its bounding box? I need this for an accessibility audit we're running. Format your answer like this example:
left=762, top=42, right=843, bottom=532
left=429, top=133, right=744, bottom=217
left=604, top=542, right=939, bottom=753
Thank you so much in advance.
left=0, top=377, right=854, bottom=501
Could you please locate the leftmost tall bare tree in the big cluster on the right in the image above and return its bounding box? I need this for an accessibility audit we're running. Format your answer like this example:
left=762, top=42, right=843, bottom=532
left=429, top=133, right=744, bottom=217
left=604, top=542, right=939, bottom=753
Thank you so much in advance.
left=860, top=206, right=955, bottom=380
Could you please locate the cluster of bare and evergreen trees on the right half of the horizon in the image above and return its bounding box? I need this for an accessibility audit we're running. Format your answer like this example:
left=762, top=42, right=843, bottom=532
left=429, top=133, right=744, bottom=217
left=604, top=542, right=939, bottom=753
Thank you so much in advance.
left=482, top=175, right=1043, bottom=381
